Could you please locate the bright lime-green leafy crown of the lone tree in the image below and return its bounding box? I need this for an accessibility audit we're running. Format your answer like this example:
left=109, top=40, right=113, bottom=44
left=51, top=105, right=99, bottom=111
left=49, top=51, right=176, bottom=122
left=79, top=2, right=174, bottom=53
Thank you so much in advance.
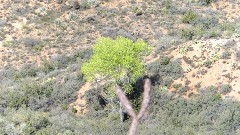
left=81, top=37, right=150, bottom=93
